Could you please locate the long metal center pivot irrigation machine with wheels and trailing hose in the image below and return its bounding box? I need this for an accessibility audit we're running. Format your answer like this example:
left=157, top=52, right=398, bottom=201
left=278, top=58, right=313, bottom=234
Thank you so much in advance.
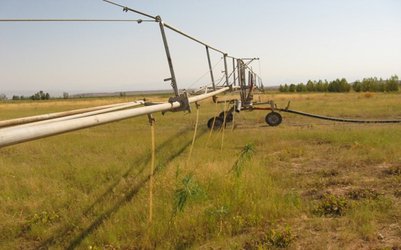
left=0, top=0, right=401, bottom=147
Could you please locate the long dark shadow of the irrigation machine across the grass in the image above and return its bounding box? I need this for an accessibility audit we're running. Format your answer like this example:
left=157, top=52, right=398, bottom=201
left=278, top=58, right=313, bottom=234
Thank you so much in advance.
left=39, top=128, right=206, bottom=249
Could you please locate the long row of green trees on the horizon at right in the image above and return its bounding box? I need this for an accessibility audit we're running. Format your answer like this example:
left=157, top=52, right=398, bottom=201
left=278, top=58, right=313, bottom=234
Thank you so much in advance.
left=279, top=75, right=400, bottom=92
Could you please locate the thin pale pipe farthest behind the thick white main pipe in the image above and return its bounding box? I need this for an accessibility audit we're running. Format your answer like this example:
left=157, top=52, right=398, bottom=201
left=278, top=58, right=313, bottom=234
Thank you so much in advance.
left=0, top=103, right=138, bottom=128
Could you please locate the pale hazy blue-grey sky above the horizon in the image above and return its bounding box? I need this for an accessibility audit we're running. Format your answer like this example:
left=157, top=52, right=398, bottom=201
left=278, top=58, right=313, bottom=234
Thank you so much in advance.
left=0, top=0, right=401, bottom=96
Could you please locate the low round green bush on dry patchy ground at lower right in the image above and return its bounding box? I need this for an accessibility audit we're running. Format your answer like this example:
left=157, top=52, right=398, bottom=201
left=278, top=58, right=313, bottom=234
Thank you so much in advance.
left=314, top=194, right=350, bottom=217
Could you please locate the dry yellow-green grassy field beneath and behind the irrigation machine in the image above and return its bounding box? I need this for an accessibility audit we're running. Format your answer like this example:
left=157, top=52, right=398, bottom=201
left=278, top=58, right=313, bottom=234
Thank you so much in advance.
left=0, top=93, right=401, bottom=249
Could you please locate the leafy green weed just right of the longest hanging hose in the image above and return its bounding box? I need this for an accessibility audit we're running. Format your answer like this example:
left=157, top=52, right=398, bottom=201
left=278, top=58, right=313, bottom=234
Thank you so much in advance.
left=174, top=173, right=203, bottom=214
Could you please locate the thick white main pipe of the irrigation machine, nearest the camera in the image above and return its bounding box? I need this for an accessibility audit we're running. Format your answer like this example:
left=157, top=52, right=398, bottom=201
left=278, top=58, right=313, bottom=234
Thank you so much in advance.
left=0, top=87, right=230, bottom=147
